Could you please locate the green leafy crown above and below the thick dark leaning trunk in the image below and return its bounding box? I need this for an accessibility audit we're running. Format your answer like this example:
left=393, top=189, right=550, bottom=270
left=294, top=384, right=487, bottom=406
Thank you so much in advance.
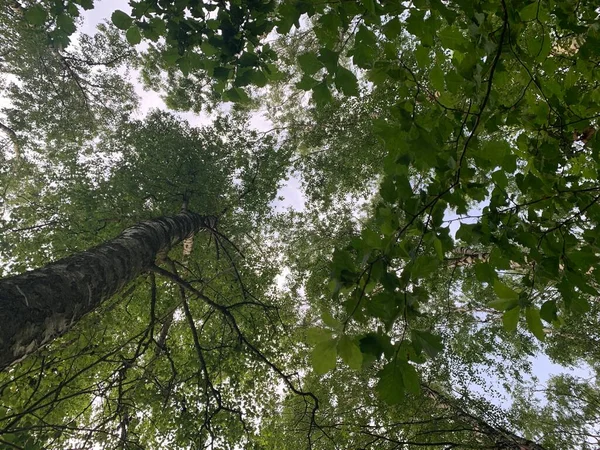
left=0, top=112, right=292, bottom=448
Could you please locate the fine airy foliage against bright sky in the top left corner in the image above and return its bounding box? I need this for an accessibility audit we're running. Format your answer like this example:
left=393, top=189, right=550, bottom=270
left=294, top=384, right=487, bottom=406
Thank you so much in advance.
left=0, top=2, right=137, bottom=150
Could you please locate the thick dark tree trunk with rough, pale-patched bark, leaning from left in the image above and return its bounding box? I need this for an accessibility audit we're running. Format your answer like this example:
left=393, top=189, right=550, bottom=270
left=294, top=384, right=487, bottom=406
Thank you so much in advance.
left=0, top=212, right=215, bottom=370
